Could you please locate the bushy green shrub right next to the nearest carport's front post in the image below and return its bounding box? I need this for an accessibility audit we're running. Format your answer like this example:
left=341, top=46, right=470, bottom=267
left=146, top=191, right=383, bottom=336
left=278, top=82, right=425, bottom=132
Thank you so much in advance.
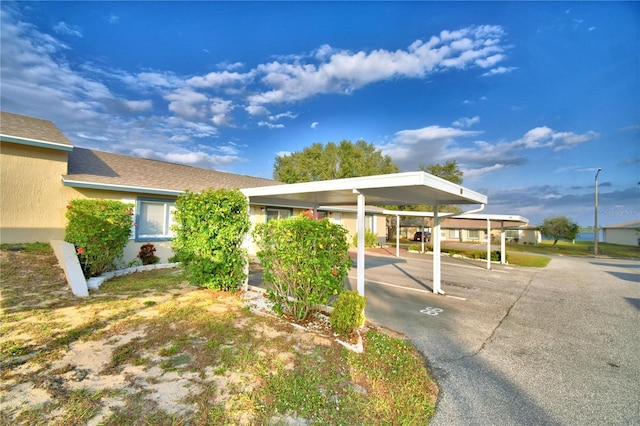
left=253, top=215, right=351, bottom=322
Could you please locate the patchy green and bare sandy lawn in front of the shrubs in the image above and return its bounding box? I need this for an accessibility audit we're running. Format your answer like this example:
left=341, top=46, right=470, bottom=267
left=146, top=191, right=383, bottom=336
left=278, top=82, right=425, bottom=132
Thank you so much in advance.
left=0, top=245, right=437, bottom=425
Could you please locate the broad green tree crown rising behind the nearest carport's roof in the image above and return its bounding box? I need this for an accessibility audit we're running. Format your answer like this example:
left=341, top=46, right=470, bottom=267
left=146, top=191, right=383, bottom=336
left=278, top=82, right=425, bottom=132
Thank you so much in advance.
left=273, top=140, right=400, bottom=183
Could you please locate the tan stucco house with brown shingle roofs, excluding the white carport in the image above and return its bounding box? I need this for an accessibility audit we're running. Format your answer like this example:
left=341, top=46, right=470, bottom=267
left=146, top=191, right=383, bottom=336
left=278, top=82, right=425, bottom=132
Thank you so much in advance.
left=0, top=112, right=386, bottom=262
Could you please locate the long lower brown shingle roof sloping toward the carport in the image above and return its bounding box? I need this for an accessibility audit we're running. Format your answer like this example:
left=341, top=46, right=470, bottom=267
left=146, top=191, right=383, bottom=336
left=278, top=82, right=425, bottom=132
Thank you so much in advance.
left=63, top=147, right=282, bottom=191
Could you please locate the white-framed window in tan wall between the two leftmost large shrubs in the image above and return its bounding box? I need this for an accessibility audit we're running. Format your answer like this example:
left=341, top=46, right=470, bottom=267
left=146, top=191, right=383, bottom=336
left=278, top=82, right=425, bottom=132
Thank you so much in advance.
left=136, top=199, right=176, bottom=241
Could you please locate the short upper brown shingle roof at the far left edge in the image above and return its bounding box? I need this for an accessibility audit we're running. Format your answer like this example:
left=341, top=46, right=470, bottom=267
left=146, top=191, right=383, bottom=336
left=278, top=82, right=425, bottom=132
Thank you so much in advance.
left=0, top=111, right=73, bottom=147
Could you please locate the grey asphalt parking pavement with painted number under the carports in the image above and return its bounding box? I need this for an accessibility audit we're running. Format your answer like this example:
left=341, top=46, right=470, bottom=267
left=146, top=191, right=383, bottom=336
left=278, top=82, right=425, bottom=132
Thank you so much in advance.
left=350, top=253, right=640, bottom=425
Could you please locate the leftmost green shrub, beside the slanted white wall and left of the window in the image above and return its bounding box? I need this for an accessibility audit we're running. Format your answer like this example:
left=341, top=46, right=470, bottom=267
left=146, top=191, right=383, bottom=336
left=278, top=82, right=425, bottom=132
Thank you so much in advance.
left=64, top=199, right=133, bottom=278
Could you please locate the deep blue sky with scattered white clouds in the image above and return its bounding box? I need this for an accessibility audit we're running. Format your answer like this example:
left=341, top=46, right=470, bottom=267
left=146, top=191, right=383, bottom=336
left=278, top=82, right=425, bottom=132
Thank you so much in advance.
left=0, top=1, right=640, bottom=226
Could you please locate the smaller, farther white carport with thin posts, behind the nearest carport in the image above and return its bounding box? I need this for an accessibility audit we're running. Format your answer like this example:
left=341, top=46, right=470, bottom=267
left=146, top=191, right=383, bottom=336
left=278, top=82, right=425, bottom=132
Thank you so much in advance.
left=382, top=210, right=529, bottom=269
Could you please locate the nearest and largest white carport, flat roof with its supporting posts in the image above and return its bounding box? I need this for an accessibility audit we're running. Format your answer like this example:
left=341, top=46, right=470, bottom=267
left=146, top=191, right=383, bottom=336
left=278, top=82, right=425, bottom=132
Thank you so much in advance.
left=241, top=172, right=487, bottom=295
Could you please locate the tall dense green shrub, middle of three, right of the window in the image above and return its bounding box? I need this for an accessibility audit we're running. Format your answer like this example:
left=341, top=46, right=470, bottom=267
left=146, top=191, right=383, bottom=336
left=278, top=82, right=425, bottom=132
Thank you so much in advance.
left=173, top=189, right=249, bottom=291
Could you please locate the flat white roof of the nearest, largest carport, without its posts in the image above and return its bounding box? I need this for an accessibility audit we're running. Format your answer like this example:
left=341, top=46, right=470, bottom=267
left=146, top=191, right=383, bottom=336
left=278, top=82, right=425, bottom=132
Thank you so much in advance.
left=241, top=172, right=487, bottom=207
